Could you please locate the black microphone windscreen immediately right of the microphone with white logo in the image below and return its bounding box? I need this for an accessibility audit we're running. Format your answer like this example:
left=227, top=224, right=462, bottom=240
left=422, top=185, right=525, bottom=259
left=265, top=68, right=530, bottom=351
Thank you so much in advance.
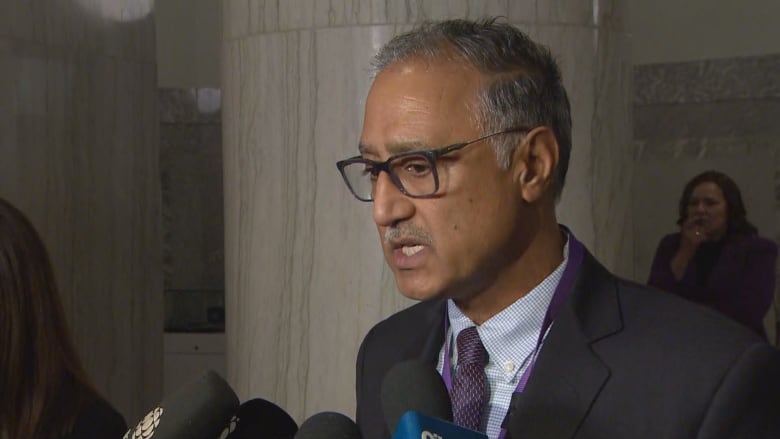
left=225, top=398, right=298, bottom=439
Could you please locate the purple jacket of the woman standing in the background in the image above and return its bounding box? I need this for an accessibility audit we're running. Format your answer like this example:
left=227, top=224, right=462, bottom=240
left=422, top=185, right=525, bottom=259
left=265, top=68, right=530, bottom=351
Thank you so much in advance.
left=648, top=233, right=777, bottom=336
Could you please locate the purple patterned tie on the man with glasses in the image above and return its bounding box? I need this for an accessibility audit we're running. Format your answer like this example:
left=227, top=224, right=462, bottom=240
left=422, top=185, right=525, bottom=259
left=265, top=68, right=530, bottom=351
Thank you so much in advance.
left=450, top=326, right=488, bottom=431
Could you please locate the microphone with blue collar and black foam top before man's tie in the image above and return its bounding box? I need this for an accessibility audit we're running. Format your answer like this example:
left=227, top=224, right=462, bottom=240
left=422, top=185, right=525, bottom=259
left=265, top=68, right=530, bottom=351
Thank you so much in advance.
left=381, top=360, right=487, bottom=439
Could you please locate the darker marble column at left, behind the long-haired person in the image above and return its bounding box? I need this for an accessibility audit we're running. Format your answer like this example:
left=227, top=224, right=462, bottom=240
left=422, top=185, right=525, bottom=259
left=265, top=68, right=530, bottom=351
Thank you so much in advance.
left=0, top=0, right=163, bottom=423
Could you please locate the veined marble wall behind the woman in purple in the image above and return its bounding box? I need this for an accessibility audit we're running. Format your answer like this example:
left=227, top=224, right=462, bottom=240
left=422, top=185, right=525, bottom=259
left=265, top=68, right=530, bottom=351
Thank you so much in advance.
left=632, top=55, right=780, bottom=342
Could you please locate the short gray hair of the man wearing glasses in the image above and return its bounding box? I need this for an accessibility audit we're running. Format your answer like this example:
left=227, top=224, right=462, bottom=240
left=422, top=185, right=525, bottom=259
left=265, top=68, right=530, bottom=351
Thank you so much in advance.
left=372, top=18, right=571, bottom=197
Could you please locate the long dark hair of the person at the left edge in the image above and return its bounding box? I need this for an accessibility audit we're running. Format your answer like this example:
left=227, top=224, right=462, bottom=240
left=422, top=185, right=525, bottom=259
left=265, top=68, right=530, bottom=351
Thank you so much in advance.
left=0, top=198, right=98, bottom=438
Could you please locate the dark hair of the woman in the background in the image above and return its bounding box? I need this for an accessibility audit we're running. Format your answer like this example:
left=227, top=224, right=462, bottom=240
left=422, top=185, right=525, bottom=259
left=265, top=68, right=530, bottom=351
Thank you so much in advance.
left=677, top=171, right=758, bottom=236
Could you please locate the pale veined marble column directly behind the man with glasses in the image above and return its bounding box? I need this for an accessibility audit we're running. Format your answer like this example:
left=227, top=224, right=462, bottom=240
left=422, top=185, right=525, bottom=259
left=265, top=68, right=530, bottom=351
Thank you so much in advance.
left=222, top=0, right=632, bottom=421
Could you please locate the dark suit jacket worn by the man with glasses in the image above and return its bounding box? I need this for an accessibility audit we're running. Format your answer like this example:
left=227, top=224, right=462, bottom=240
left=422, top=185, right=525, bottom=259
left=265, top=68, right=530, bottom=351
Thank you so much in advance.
left=357, top=252, right=780, bottom=439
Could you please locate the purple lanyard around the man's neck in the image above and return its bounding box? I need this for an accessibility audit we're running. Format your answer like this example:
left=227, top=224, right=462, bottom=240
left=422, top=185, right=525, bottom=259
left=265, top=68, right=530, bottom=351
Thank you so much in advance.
left=442, top=233, right=585, bottom=439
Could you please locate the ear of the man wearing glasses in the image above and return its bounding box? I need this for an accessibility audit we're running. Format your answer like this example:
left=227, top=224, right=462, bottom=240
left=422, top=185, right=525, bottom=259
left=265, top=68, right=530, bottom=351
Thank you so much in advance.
left=512, top=127, right=558, bottom=203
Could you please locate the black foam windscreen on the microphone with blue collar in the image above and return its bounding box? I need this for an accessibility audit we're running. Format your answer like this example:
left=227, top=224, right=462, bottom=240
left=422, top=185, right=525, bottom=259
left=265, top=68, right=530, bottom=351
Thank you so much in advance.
left=381, top=360, right=452, bottom=431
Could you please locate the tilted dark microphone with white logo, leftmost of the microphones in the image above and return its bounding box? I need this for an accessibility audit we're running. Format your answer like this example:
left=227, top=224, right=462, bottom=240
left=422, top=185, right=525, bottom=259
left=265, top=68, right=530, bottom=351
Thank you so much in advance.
left=124, top=370, right=238, bottom=439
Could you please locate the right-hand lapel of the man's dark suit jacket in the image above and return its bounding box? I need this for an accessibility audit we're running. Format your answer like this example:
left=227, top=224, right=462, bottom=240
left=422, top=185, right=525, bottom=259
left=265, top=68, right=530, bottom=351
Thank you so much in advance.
left=504, top=253, right=622, bottom=439
